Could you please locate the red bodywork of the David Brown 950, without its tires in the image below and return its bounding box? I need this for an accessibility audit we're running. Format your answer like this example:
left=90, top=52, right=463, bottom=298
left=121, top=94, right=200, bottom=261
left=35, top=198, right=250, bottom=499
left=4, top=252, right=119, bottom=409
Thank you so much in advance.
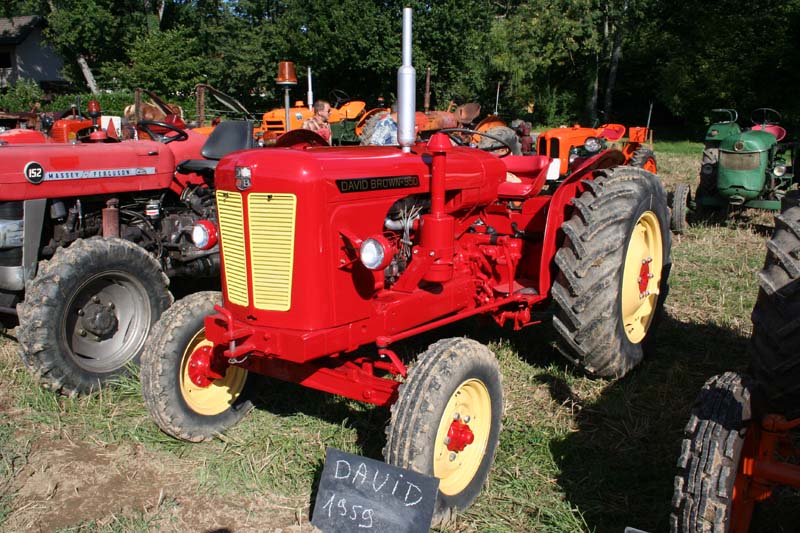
left=190, top=134, right=624, bottom=408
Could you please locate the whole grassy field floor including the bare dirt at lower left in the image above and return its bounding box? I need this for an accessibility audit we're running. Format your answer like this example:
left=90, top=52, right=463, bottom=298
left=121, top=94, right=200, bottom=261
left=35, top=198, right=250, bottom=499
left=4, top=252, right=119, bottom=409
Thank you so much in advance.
left=0, top=143, right=800, bottom=533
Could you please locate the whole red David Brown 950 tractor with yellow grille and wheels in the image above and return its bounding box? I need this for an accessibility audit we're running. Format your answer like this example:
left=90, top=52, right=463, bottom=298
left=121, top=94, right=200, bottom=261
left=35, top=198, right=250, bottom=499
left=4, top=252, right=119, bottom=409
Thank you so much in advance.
left=140, top=8, right=671, bottom=522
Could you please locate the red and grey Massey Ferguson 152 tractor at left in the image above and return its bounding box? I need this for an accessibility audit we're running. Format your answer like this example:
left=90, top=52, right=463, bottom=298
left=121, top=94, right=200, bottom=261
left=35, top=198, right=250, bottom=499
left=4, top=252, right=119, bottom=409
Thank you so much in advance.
left=0, top=103, right=252, bottom=394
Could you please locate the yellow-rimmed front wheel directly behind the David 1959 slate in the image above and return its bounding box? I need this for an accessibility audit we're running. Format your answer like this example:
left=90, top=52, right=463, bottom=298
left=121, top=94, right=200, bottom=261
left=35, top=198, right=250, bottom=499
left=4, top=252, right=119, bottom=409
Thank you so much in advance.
left=384, top=338, right=503, bottom=525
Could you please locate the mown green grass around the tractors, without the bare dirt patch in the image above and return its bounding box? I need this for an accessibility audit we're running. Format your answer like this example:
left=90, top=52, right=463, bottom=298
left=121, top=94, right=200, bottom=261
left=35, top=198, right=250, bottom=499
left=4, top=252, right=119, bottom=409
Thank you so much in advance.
left=0, top=143, right=800, bottom=532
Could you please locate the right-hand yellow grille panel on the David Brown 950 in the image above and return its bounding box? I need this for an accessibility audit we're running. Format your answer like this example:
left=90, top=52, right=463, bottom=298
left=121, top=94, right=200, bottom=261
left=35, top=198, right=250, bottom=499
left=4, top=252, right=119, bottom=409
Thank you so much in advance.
left=247, top=193, right=297, bottom=311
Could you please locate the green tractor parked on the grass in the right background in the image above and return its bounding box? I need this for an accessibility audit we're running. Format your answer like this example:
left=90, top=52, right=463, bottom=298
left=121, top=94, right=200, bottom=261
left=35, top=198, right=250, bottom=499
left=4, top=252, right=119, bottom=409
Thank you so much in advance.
left=671, top=107, right=798, bottom=233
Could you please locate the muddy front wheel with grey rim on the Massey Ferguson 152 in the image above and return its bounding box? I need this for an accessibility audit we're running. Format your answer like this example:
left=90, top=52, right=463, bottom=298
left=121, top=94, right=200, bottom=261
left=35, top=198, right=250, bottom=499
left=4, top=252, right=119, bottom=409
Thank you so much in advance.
left=17, top=237, right=172, bottom=395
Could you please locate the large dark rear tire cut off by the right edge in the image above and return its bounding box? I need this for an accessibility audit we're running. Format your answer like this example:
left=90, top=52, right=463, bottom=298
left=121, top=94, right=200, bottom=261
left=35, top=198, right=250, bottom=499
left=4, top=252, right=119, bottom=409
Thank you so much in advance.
left=750, top=191, right=800, bottom=418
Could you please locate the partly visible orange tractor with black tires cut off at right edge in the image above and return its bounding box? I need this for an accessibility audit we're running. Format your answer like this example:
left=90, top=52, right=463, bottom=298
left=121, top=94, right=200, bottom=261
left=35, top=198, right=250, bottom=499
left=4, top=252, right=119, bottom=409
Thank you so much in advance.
left=671, top=191, right=800, bottom=533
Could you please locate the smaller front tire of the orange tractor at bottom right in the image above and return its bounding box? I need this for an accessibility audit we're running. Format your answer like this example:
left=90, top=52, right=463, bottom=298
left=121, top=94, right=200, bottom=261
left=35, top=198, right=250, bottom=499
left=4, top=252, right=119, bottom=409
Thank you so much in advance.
left=670, top=372, right=752, bottom=533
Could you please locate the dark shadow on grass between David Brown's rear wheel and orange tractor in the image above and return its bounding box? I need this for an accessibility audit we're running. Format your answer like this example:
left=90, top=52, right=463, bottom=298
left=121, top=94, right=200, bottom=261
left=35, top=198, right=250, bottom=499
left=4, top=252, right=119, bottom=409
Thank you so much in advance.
left=543, top=317, right=800, bottom=532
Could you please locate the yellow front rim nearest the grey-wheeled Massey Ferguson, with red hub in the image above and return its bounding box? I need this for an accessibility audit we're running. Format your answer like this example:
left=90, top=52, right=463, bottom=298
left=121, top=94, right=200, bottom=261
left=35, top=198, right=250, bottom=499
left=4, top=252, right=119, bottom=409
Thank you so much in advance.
left=180, top=328, right=247, bottom=416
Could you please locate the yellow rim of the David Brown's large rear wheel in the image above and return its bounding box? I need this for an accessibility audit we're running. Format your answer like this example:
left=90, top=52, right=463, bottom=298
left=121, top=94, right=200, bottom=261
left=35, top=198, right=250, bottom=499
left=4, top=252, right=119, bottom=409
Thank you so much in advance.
left=622, top=211, right=664, bottom=344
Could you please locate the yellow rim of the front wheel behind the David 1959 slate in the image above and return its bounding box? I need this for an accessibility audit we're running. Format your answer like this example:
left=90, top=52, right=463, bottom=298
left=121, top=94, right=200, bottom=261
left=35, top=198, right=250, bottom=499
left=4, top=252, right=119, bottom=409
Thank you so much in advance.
left=433, top=379, right=492, bottom=496
